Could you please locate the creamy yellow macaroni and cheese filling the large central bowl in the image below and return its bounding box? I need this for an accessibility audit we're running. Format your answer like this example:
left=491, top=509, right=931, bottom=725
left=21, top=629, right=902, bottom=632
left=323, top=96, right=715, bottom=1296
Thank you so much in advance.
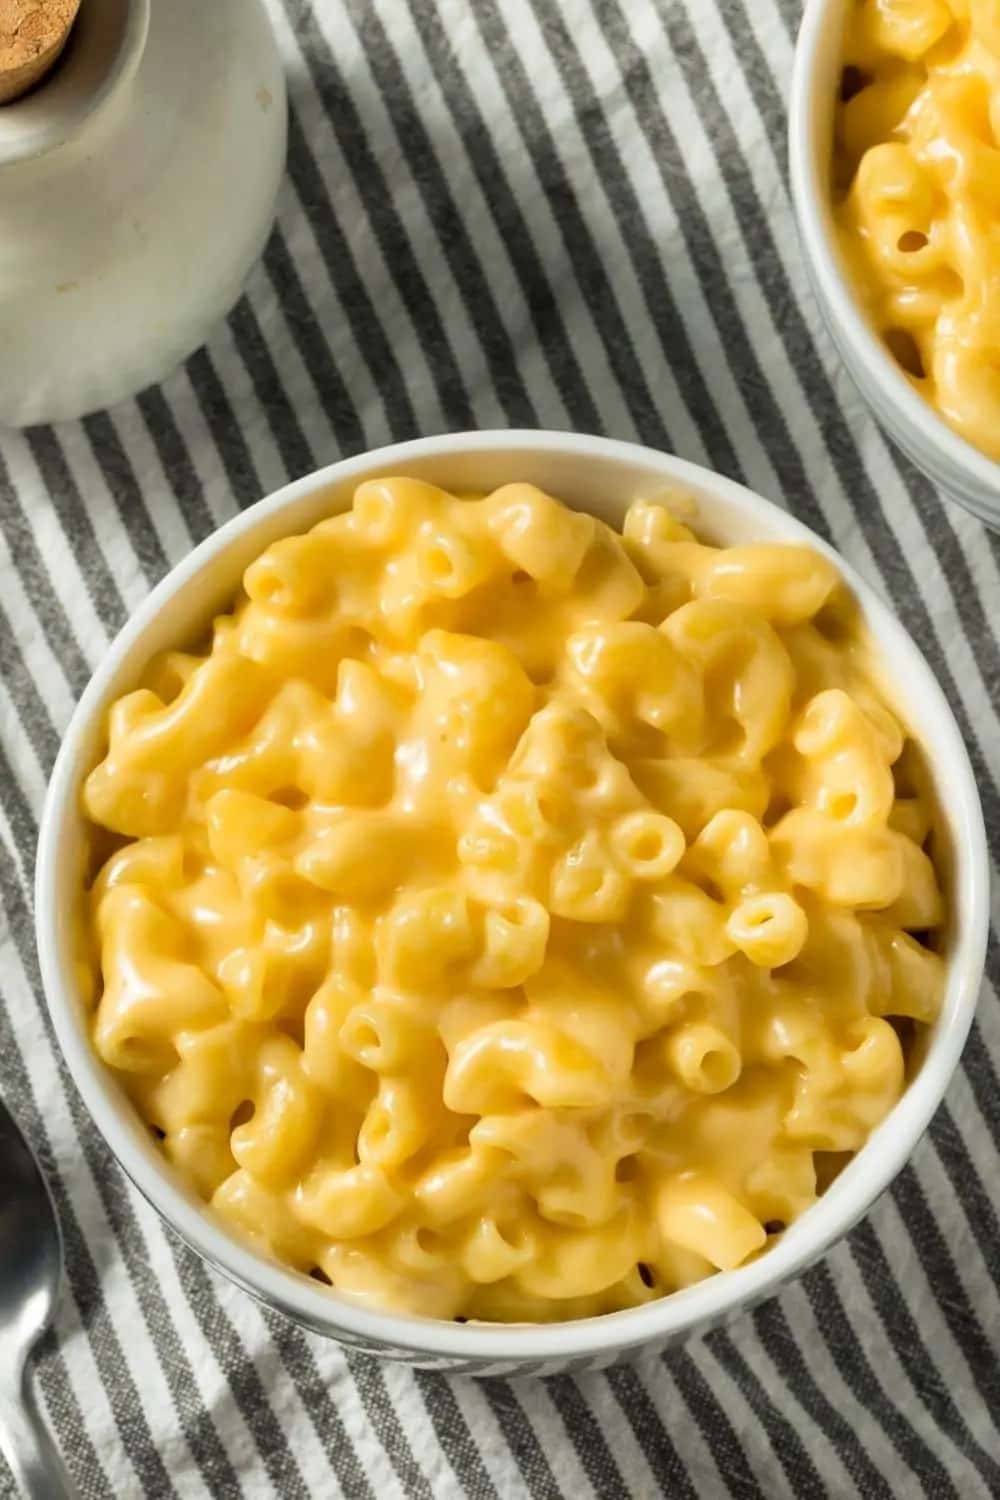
left=84, top=479, right=945, bottom=1319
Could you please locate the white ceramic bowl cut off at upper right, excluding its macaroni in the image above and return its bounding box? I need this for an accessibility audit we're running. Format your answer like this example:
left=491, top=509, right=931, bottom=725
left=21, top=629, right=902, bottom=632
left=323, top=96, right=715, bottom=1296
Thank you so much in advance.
left=789, top=0, right=1000, bottom=528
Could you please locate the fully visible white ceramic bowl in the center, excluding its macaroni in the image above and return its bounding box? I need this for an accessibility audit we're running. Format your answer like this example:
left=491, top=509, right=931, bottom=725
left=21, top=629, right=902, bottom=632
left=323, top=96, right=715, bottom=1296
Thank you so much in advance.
left=36, top=432, right=988, bottom=1374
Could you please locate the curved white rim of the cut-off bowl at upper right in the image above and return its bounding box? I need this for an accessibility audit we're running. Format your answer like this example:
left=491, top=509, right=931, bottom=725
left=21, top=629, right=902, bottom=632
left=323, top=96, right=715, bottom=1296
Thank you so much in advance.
left=787, top=0, right=1000, bottom=492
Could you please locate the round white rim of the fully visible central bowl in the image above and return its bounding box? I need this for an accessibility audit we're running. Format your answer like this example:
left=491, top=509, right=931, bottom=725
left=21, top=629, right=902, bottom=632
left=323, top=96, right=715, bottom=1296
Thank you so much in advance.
left=34, top=431, right=990, bottom=1364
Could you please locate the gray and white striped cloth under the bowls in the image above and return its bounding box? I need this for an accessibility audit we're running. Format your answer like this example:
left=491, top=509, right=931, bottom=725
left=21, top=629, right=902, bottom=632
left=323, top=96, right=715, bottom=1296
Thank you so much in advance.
left=0, top=0, right=1000, bottom=1500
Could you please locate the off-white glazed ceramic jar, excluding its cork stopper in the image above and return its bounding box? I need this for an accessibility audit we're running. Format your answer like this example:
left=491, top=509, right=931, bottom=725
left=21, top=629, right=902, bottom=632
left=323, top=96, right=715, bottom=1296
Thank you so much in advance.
left=0, top=0, right=286, bottom=426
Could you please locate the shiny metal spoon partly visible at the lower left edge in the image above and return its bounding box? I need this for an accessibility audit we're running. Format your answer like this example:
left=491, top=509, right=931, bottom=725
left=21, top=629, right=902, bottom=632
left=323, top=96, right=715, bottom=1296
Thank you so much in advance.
left=0, top=1100, right=75, bottom=1500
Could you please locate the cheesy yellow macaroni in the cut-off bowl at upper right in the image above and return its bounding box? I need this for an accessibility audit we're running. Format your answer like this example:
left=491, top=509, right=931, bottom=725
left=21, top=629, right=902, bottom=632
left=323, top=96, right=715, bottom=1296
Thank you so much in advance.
left=834, top=0, right=1000, bottom=459
